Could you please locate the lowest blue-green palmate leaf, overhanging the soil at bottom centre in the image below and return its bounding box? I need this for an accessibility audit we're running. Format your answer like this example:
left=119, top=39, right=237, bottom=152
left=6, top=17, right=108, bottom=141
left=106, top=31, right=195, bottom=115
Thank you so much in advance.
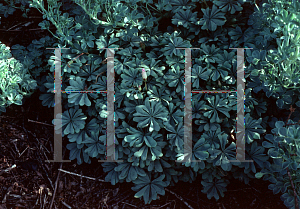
left=131, top=174, right=167, bottom=204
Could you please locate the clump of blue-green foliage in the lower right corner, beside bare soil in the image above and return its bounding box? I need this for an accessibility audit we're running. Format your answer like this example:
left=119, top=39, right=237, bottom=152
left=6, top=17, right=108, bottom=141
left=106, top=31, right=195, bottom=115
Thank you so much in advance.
left=255, top=120, right=300, bottom=208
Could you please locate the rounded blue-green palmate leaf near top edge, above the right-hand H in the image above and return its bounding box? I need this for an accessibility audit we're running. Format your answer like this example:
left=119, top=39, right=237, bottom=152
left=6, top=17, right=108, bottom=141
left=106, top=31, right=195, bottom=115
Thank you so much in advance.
left=197, top=5, right=226, bottom=31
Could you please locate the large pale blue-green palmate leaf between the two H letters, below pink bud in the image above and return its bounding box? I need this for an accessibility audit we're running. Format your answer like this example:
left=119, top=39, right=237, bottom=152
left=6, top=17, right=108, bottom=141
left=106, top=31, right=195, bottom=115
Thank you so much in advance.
left=133, top=98, right=168, bottom=132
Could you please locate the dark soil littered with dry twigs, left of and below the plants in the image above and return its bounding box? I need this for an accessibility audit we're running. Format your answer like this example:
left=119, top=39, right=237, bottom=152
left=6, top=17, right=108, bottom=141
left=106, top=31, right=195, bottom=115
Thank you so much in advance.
left=0, top=0, right=286, bottom=209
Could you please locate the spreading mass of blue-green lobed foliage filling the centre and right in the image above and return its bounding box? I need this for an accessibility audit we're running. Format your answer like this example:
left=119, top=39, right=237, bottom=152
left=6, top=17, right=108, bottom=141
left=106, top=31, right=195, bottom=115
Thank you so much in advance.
left=1, top=0, right=300, bottom=208
